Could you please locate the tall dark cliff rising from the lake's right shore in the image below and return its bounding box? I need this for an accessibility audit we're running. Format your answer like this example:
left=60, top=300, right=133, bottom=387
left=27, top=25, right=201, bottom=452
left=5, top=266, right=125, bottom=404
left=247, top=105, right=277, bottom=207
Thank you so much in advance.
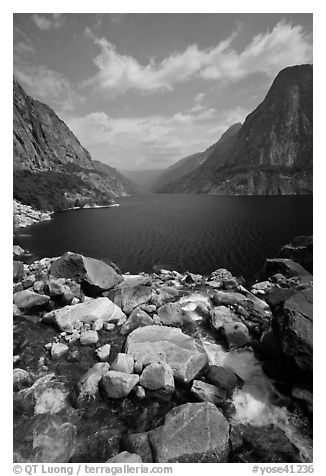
left=160, top=65, right=313, bottom=195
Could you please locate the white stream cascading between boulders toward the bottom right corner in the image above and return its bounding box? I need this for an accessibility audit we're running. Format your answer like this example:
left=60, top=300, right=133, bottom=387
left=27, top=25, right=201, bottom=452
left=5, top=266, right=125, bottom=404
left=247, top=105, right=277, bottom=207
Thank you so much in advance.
left=180, top=292, right=313, bottom=462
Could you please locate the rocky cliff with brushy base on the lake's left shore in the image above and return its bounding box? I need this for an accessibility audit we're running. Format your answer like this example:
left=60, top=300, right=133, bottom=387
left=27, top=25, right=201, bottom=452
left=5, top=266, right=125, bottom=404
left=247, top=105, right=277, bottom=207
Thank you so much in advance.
left=13, top=80, right=135, bottom=210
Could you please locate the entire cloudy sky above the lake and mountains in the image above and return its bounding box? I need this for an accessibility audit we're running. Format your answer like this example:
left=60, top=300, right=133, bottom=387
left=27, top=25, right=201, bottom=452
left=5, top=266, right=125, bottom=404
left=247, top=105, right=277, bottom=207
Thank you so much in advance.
left=13, top=13, right=312, bottom=170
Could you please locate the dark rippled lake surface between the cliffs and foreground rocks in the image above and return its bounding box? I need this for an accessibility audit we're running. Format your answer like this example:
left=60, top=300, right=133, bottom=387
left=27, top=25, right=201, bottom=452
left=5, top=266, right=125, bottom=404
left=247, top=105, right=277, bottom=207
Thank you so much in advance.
left=15, top=194, right=313, bottom=281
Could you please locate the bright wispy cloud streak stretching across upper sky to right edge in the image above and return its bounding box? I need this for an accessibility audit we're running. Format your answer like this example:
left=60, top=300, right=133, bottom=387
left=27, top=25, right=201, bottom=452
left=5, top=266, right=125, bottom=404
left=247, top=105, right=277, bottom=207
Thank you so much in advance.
left=82, top=21, right=312, bottom=94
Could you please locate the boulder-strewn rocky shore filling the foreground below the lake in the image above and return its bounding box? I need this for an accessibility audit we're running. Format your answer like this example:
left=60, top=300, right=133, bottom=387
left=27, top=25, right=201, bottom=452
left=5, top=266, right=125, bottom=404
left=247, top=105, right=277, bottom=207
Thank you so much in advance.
left=13, top=238, right=312, bottom=463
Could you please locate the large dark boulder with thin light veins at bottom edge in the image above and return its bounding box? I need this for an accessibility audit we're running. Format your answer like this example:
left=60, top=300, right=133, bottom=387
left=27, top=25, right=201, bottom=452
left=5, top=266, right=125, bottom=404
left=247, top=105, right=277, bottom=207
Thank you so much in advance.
left=149, top=402, right=229, bottom=463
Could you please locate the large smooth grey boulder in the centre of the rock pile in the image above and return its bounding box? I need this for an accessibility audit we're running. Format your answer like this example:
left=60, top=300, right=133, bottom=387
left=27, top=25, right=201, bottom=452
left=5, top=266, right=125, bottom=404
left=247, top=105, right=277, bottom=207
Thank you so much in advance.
left=126, top=326, right=208, bottom=383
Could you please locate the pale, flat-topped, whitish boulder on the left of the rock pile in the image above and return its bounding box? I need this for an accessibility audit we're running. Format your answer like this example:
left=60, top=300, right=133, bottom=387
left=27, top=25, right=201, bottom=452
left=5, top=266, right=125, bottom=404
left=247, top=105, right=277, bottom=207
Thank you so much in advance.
left=43, top=298, right=126, bottom=332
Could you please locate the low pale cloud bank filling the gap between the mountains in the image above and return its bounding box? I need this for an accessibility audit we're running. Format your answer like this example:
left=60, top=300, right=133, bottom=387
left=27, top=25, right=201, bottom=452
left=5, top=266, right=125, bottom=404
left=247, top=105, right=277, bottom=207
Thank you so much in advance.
left=65, top=108, right=246, bottom=169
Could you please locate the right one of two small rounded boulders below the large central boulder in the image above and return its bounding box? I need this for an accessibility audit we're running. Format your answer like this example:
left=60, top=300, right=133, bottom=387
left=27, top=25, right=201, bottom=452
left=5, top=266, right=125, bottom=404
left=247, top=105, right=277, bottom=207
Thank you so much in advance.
left=139, top=362, right=174, bottom=392
